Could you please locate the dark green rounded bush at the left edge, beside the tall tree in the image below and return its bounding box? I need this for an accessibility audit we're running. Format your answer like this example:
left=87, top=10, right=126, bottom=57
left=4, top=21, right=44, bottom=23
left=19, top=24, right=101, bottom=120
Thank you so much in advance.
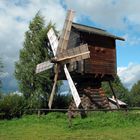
left=0, top=94, right=26, bottom=119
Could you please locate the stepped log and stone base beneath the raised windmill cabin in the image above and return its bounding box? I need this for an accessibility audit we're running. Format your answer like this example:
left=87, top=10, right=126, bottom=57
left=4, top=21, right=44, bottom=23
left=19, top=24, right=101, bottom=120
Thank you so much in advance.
left=68, top=87, right=111, bottom=118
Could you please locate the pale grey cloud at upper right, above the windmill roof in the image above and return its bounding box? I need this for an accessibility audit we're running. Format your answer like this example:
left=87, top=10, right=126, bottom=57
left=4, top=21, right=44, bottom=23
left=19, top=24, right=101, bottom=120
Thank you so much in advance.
left=66, top=0, right=140, bottom=29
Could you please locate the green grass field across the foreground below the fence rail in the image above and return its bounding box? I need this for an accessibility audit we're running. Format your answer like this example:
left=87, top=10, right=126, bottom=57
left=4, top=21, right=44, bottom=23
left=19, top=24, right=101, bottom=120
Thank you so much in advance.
left=0, top=112, right=140, bottom=140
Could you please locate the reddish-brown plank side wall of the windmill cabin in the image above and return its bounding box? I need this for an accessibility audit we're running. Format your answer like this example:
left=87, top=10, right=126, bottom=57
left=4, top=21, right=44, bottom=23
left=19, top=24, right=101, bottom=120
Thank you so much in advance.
left=84, top=46, right=116, bottom=75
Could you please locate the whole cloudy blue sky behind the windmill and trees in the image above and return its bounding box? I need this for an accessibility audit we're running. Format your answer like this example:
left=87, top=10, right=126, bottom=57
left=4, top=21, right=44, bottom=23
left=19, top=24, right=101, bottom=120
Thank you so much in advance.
left=0, top=0, right=140, bottom=92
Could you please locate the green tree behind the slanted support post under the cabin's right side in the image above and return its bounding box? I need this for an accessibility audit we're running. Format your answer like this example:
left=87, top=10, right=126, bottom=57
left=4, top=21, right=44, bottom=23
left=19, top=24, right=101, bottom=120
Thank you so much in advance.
left=102, top=76, right=130, bottom=105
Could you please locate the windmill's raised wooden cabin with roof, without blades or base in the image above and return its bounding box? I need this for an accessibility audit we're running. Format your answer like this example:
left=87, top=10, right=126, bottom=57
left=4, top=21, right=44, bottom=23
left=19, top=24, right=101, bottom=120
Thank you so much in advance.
left=60, top=23, right=124, bottom=81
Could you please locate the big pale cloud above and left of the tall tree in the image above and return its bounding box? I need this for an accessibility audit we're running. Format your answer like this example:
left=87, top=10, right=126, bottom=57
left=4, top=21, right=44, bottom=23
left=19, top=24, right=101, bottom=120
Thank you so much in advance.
left=0, top=0, right=65, bottom=92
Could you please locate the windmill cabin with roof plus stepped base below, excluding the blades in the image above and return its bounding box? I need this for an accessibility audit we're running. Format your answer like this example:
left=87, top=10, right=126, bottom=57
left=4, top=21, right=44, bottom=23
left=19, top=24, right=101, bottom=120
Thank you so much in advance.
left=64, top=23, right=124, bottom=114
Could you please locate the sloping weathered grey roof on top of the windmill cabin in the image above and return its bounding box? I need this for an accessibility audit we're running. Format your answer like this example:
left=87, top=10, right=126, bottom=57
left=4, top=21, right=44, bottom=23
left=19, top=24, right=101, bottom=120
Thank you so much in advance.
left=72, top=22, right=125, bottom=41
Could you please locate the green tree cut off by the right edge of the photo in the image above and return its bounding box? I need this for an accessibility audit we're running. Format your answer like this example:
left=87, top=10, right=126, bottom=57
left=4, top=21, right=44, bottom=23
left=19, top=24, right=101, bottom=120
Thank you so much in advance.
left=130, top=80, right=140, bottom=106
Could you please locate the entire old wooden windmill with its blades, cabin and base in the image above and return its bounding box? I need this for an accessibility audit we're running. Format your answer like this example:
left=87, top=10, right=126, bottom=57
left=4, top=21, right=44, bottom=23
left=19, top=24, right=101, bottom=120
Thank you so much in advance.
left=36, top=10, right=124, bottom=114
